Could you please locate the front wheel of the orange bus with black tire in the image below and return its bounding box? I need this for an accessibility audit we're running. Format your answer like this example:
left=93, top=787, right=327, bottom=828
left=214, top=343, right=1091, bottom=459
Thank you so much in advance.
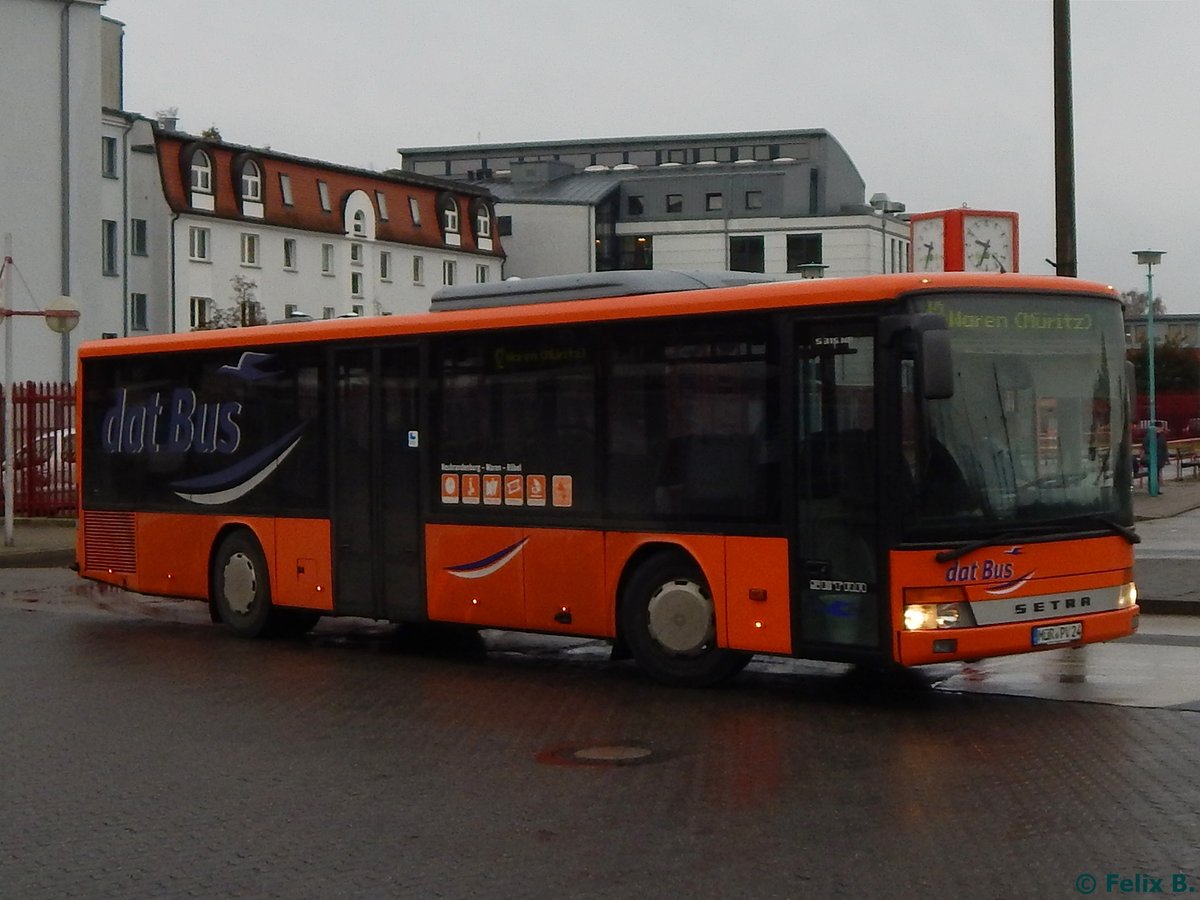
left=620, top=553, right=754, bottom=688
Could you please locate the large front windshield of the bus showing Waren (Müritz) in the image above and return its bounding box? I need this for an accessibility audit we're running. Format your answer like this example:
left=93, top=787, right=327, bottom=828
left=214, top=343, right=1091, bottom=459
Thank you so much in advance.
left=901, top=294, right=1132, bottom=536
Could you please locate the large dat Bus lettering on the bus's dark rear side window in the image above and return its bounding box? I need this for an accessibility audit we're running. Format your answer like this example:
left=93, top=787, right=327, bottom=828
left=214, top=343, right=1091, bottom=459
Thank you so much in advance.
left=102, top=388, right=241, bottom=454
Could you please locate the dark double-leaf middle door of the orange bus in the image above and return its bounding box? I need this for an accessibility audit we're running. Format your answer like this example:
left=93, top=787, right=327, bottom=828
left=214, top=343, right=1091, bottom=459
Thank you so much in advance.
left=331, top=347, right=426, bottom=622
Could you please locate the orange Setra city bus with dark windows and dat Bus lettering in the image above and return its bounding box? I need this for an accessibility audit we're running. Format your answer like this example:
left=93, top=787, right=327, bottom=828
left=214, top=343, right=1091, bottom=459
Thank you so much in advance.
left=70, top=271, right=1139, bottom=685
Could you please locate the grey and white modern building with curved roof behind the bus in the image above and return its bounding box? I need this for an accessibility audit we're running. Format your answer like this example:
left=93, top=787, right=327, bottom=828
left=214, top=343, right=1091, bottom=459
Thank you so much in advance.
left=400, top=128, right=908, bottom=277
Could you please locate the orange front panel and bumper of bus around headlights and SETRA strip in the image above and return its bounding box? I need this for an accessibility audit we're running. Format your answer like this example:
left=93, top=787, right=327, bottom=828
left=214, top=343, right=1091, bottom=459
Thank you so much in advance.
left=890, top=535, right=1139, bottom=666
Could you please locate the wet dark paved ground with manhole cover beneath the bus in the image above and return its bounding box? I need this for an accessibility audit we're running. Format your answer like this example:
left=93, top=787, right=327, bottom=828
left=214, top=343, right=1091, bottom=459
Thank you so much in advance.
left=0, top=570, right=1200, bottom=898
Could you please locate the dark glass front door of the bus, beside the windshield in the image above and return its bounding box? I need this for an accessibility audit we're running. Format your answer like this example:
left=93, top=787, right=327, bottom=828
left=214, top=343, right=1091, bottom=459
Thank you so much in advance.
left=792, top=322, right=881, bottom=648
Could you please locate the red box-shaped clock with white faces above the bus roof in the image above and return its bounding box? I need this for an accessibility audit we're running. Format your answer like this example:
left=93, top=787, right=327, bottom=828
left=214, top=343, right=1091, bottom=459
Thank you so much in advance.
left=908, top=208, right=1019, bottom=272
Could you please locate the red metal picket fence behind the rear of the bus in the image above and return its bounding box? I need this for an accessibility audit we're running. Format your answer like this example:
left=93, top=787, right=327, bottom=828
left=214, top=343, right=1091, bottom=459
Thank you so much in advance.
left=0, top=382, right=76, bottom=516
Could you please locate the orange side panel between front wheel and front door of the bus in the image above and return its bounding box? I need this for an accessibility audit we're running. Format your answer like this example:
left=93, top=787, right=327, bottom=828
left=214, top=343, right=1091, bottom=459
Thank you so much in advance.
left=725, top=538, right=792, bottom=653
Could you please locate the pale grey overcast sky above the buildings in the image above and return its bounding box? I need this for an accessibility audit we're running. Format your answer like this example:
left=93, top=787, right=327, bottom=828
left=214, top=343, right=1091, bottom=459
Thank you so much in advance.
left=103, top=0, right=1200, bottom=312
